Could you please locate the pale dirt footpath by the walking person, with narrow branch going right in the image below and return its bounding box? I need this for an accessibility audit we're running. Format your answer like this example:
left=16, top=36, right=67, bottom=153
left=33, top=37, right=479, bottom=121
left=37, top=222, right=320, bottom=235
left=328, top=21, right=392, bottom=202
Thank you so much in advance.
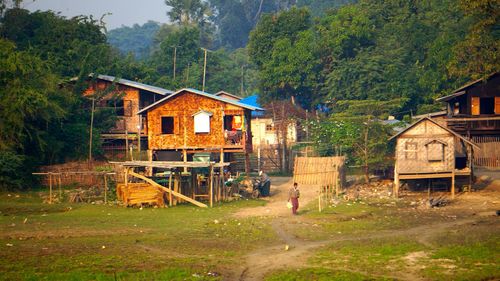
left=231, top=178, right=498, bottom=281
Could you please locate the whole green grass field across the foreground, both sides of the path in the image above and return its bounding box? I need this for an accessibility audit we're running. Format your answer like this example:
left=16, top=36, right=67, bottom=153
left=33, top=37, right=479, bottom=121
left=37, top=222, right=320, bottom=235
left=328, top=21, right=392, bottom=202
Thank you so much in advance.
left=0, top=184, right=500, bottom=280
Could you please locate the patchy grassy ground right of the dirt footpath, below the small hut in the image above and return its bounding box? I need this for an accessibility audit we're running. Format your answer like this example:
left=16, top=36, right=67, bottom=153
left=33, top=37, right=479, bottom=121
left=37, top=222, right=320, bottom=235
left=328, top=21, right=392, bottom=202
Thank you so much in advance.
left=266, top=197, right=500, bottom=280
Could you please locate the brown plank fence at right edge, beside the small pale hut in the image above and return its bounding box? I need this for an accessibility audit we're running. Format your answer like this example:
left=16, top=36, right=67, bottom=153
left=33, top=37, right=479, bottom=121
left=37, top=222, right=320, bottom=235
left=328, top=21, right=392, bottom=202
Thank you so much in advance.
left=472, top=136, right=500, bottom=168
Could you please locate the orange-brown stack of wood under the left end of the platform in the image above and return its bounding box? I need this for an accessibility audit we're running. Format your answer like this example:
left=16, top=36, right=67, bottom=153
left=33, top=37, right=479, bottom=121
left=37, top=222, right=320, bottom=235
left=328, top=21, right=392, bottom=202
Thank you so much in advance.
left=116, top=183, right=165, bottom=207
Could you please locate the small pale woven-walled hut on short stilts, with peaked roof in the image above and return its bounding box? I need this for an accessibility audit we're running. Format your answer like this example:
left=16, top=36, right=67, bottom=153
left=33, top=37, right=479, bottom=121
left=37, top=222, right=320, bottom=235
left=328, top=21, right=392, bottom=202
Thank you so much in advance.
left=391, top=117, right=478, bottom=197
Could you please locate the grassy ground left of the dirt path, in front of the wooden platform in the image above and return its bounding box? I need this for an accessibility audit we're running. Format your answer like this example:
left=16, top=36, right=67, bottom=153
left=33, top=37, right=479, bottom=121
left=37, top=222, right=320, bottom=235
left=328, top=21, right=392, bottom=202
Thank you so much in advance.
left=0, top=189, right=276, bottom=280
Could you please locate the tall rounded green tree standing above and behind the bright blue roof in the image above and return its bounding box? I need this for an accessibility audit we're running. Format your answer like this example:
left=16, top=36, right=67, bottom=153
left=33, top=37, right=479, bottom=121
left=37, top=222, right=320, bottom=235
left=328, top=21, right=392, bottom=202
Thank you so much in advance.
left=248, top=8, right=319, bottom=108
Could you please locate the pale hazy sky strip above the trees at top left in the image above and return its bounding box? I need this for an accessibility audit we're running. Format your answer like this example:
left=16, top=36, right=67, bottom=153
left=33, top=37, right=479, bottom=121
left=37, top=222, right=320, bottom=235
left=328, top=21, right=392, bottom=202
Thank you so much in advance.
left=21, top=0, right=168, bottom=30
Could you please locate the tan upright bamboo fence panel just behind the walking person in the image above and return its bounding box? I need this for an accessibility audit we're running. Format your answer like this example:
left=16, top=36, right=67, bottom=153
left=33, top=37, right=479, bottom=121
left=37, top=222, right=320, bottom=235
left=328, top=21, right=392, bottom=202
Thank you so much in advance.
left=293, top=157, right=345, bottom=186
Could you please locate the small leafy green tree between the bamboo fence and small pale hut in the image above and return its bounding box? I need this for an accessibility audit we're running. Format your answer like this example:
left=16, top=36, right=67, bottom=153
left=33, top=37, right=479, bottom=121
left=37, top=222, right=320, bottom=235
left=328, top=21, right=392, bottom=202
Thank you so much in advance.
left=312, top=100, right=401, bottom=182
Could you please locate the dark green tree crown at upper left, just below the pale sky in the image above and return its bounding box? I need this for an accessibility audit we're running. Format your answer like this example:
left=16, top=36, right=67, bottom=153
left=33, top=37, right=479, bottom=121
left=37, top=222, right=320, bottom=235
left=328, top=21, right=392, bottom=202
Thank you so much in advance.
left=0, top=9, right=116, bottom=77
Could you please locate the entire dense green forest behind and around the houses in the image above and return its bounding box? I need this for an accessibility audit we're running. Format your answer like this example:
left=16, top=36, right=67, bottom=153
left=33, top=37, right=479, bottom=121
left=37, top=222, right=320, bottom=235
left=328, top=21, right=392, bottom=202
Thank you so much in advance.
left=0, top=0, right=500, bottom=187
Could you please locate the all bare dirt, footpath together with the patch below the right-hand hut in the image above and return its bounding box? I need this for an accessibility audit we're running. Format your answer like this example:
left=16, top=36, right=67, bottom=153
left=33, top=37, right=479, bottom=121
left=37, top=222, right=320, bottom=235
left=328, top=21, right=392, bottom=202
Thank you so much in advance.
left=231, top=174, right=500, bottom=280
